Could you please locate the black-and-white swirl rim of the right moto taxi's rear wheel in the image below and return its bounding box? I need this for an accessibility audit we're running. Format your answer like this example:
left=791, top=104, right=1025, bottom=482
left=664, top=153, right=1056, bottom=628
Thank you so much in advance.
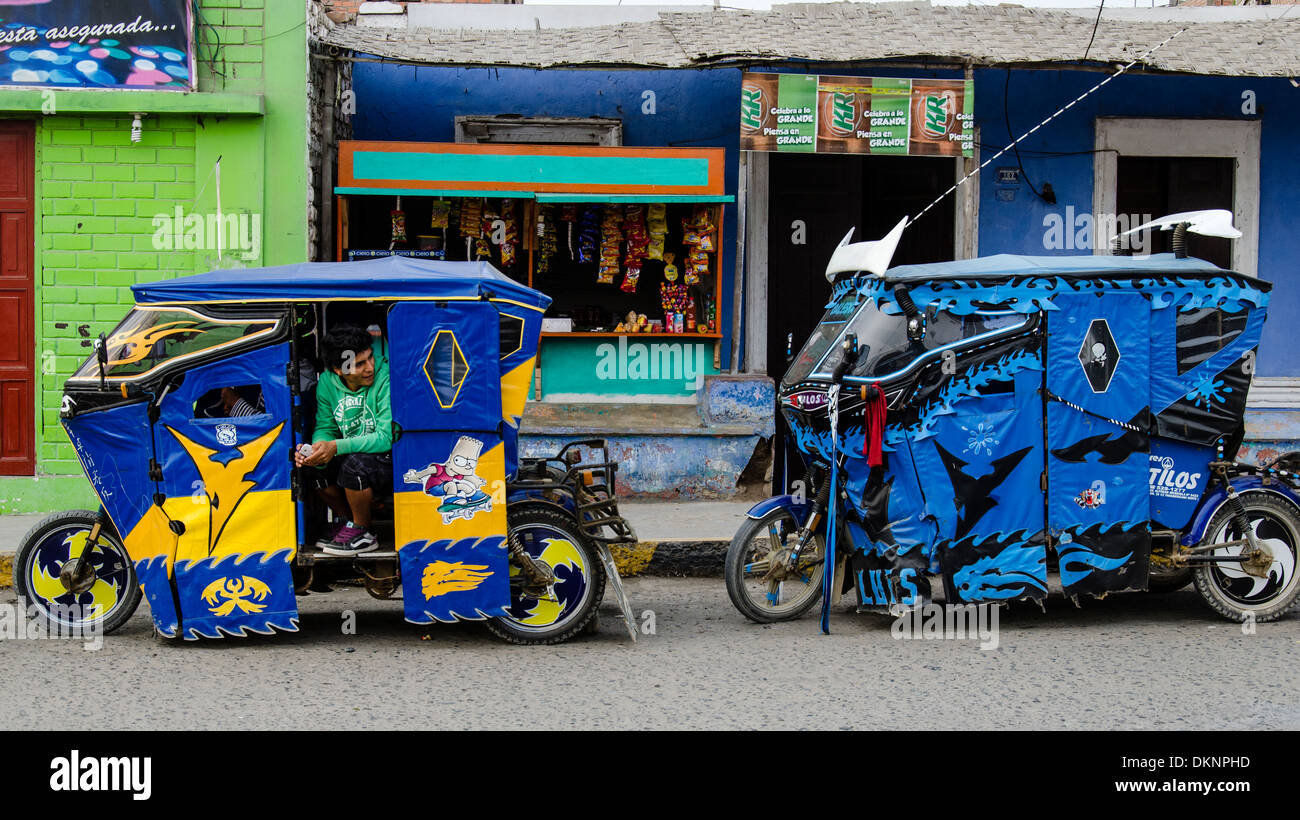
left=1209, top=508, right=1300, bottom=609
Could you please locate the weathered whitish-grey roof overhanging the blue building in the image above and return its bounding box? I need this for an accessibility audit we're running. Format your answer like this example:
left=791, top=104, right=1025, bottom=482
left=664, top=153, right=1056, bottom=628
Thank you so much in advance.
left=321, top=3, right=1300, bottom=77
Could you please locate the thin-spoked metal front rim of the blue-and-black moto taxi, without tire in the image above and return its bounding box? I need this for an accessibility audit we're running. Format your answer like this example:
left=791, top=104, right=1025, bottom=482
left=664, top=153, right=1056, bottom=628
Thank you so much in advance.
left=741, top=513, right=826, bottom=616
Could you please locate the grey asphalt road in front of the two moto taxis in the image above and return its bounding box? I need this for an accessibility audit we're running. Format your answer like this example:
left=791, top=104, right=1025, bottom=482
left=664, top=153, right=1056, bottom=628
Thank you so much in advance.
left=0, top=577, right=1300, bottom=730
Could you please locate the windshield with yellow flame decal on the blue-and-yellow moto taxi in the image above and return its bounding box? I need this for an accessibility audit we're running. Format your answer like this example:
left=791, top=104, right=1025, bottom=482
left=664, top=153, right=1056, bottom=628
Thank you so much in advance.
left=73, top=307, right=276, bottom=379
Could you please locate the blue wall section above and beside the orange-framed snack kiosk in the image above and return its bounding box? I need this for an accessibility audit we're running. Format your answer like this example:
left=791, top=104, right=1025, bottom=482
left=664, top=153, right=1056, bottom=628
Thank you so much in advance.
left=352, top=62, right=741, bottom=368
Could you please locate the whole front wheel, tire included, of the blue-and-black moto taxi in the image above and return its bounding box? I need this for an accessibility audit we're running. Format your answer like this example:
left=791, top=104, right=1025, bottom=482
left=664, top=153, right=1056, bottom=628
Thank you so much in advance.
left=727, top=508, right=826, bottom=624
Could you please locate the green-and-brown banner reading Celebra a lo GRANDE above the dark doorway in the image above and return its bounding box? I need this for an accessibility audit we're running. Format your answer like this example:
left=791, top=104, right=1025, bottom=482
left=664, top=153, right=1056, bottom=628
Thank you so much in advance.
left=740, top=71, right=975, bottom=157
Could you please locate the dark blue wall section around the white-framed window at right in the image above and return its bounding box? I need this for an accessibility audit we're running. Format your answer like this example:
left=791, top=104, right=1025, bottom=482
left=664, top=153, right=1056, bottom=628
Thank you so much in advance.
left=975, top=70, right=1300, bottom=376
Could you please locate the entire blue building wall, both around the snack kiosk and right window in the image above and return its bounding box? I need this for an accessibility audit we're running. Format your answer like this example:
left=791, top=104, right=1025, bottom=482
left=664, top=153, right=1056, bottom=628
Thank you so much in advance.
left=354, top=62, right=1300, bottom=376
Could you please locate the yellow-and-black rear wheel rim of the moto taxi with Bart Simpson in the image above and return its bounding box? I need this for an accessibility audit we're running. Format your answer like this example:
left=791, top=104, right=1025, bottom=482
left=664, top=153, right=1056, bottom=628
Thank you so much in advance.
left=506, top=524, right=594, bottom=633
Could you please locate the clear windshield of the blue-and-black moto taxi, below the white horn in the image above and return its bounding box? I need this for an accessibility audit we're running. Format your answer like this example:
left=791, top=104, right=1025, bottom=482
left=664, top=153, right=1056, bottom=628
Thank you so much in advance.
left=785, top=296, right=1028, bottom=383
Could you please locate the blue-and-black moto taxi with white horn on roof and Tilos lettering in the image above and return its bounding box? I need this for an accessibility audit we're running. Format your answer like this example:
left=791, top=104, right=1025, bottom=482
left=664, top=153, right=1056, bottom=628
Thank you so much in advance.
left=727, top=214, right=1300, bottom=629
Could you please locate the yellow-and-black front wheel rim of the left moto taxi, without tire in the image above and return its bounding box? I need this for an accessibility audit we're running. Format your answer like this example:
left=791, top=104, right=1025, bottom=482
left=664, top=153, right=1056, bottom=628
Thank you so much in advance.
left=20, top=524, right=131, bottom=629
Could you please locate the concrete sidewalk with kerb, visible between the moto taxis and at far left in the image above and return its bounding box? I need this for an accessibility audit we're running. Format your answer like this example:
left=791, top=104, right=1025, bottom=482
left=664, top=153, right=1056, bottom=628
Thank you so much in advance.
left=0, top=502, right=753, bottom=587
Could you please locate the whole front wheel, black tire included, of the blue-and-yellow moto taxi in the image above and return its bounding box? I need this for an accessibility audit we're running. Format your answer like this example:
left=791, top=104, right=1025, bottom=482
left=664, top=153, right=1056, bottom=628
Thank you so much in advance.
left=13, top=509, right=142, bottom=635
